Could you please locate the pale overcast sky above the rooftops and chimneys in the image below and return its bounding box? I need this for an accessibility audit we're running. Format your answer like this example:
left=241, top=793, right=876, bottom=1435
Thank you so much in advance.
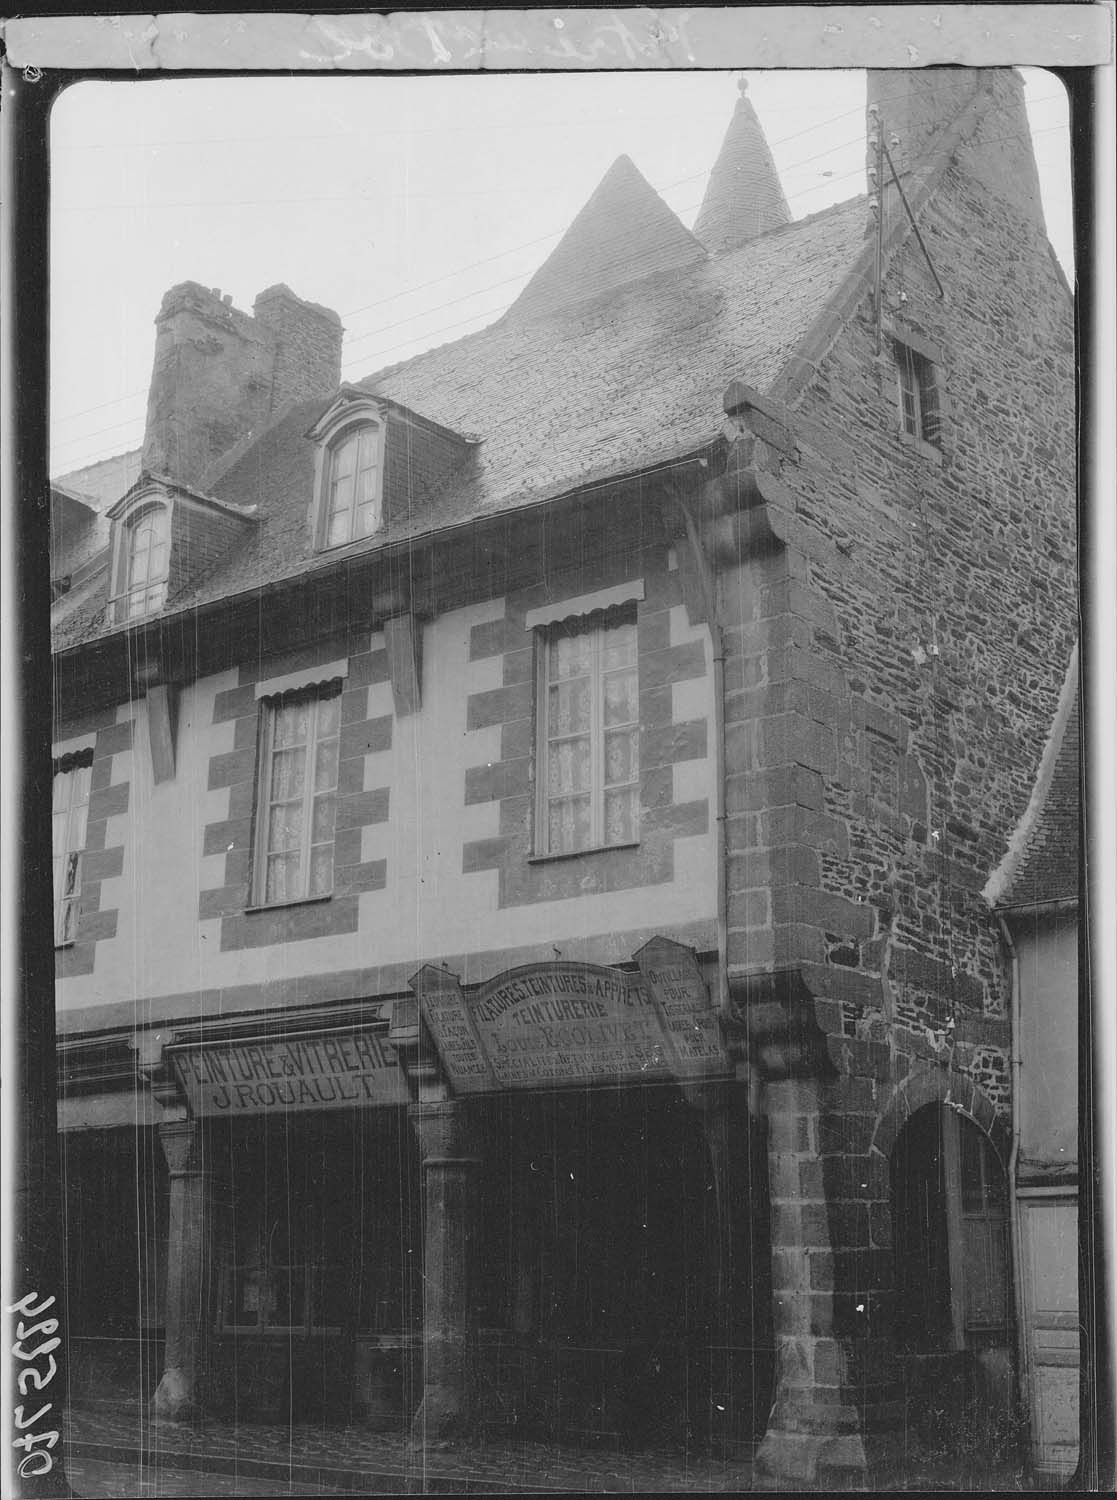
left=51, top=69, right=1072, bottom=474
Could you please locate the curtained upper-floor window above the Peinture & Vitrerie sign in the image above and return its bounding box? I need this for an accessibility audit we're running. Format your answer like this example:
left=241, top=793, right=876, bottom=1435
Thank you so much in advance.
left=253, top=683, right=342, bottom=906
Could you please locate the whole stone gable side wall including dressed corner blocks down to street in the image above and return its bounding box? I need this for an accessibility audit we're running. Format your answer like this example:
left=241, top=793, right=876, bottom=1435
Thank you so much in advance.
left=720, top=70, right=1077, bottom=1463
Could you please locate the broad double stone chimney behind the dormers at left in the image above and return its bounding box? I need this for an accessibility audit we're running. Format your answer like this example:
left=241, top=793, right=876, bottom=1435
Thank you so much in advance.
left=142, top=282, right=342, bottom=489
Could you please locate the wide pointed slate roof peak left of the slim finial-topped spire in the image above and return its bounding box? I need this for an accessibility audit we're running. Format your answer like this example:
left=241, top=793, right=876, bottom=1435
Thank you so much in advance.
left=507, top=156, right=706, bottom=323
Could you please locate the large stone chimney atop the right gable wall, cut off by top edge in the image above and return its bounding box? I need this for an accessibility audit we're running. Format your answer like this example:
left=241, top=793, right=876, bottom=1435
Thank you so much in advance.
left=867, top=68, right=1044, bottom=228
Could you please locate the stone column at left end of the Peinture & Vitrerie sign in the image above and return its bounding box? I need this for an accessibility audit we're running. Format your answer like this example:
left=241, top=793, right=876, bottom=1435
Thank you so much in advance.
left=151, top=1119, right=207, bottom=1421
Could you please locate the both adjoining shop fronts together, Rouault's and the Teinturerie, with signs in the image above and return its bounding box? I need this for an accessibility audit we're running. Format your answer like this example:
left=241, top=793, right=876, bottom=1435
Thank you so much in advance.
left=143, top=939, right=771, bottom=1443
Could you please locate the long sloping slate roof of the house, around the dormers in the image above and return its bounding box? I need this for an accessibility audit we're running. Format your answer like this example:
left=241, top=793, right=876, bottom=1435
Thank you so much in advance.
left=54, top=178, right=865, bottom=650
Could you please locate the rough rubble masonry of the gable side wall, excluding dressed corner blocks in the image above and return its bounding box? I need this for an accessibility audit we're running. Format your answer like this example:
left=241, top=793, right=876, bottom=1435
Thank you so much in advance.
left=781, top=120, right=1075, bottom=1103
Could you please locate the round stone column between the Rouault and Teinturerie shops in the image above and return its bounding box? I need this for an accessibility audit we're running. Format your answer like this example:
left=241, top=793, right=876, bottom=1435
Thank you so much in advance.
left=411, top=1101, right=480, bottom=1443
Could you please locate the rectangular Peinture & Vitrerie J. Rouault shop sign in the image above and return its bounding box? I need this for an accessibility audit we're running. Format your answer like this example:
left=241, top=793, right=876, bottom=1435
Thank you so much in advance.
left=169, top=1031, right=408, bottom=1116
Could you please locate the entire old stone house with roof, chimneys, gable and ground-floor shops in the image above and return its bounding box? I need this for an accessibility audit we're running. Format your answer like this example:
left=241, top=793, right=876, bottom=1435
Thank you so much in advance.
left=54, top=69, right=1075, bottom=1482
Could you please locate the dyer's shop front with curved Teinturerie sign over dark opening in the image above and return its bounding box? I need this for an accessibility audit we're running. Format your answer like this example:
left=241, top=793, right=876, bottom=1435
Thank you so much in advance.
left=391, top=938, right=771, bottom=1443
